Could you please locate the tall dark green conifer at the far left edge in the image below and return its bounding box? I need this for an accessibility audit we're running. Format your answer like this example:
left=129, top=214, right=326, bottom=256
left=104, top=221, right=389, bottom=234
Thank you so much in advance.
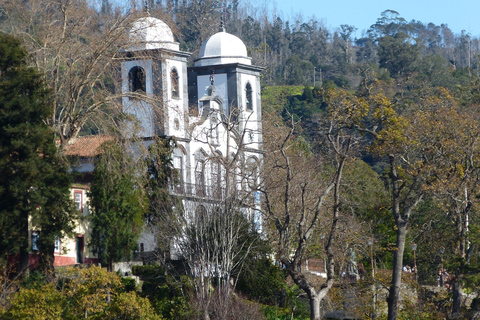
left=0, top=34, right=76, bottom=271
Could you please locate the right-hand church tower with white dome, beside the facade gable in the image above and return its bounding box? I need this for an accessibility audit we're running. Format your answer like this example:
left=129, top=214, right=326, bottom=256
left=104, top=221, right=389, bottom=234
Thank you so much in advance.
left=188, top=27, right=263, bottom=168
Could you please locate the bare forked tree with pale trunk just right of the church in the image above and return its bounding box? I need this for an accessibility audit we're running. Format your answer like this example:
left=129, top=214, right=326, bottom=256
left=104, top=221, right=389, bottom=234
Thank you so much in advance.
left=262, top=87, right=367, bottom=319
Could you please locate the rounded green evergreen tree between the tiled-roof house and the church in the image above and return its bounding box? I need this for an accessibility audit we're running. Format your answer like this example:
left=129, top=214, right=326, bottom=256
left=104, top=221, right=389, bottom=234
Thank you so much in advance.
left=89, top=142, right=145, bottom=271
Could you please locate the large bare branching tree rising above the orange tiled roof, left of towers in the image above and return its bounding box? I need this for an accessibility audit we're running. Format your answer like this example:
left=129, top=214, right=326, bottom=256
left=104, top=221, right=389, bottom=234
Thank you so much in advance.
left=0, top=0, right=142, bottom=145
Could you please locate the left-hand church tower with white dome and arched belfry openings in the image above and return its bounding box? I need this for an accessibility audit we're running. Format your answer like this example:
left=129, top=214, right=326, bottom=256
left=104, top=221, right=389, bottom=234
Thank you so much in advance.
left=122, top=17, right=190, bottom=140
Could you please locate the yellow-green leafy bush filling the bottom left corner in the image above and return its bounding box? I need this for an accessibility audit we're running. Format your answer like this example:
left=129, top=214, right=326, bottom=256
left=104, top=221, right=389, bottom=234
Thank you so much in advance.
left=0, top=267, right=162, bottom=320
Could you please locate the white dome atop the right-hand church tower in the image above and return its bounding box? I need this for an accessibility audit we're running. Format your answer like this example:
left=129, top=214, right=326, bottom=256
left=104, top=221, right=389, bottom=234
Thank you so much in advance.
left=195, top=31, right=252, bottom=67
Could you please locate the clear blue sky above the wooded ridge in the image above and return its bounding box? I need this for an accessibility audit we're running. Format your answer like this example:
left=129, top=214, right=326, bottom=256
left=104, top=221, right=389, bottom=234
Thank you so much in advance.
left=266, top=0, right=480, bottom=37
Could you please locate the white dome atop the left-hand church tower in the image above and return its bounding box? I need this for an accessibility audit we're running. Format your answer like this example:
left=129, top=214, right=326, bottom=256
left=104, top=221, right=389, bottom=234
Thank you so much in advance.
left=130, top=17, right=180, bottom=51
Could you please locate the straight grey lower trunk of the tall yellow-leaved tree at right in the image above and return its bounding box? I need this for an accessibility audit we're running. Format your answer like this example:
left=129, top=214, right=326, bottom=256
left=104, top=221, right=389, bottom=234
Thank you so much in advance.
left=387, top=223, right=407, bottom=320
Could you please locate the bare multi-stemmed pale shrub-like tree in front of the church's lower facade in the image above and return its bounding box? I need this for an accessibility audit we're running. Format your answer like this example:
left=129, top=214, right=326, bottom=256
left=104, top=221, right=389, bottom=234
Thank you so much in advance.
left=178, top=198, right=258, bottom=319
